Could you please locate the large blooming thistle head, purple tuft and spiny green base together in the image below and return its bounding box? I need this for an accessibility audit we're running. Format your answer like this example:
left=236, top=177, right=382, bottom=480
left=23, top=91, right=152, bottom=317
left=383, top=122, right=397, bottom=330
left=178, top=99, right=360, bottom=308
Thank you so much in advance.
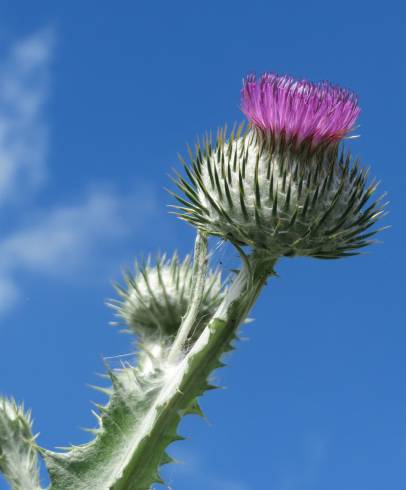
left=177, top=74, right=382, bottom=258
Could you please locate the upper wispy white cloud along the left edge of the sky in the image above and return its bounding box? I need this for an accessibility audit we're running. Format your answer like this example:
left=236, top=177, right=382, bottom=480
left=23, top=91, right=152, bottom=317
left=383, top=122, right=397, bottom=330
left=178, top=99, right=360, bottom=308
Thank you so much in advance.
left=0, top=29, right=54, bottom=204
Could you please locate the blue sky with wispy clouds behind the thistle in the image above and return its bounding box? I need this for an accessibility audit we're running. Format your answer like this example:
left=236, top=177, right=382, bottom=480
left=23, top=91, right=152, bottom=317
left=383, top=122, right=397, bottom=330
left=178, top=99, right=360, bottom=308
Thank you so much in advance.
left=0, top=0, right=406, bottom=490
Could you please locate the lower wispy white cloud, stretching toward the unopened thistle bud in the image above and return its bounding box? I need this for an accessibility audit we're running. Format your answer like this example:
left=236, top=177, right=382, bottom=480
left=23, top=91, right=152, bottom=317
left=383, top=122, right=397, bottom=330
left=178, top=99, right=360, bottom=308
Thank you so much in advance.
left=0, top=185, right=156, bottom=314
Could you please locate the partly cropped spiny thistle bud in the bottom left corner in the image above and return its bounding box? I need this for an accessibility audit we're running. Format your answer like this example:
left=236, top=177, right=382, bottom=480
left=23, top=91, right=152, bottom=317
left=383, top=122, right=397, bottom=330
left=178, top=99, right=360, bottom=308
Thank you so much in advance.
left=0, top=398, right=40, bottom=490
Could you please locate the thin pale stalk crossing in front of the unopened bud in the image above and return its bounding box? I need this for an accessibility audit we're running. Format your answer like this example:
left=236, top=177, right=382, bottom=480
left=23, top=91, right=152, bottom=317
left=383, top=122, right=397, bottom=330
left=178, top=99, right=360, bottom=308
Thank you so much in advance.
left=168, top=231, right=207, bottom=363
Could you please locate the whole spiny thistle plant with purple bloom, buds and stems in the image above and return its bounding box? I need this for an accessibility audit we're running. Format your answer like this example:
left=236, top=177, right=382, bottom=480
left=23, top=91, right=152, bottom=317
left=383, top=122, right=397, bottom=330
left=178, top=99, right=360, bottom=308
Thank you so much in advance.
left=0, top=74, right=384, bottom=490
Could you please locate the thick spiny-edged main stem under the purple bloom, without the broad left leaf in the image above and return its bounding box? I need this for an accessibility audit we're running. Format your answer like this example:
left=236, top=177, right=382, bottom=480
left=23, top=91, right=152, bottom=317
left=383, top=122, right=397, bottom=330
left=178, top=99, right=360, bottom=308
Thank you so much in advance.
left=113, top=257, right=276, bottom=490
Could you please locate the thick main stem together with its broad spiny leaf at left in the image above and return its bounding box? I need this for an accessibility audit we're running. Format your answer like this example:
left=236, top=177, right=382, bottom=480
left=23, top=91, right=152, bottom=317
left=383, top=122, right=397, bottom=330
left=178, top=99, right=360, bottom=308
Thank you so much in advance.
left=44, top=253, right=276, bottom=490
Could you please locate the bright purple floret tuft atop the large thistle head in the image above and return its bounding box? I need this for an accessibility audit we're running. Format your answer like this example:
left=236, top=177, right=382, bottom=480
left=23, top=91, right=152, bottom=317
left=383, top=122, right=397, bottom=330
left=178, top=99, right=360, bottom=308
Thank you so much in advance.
left=241, top=73, right=360, bottom=144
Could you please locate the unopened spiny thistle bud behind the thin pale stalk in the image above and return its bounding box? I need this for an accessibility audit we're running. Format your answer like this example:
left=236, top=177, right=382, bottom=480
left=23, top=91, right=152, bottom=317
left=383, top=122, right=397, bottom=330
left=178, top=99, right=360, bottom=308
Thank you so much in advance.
left=111, top=254, right=224, bottom=339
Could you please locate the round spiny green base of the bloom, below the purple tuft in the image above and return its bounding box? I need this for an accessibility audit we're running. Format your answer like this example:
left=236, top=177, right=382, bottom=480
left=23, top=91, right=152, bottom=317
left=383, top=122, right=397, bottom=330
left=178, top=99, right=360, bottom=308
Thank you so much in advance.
left=177, top=126, right=382, bottom=258
